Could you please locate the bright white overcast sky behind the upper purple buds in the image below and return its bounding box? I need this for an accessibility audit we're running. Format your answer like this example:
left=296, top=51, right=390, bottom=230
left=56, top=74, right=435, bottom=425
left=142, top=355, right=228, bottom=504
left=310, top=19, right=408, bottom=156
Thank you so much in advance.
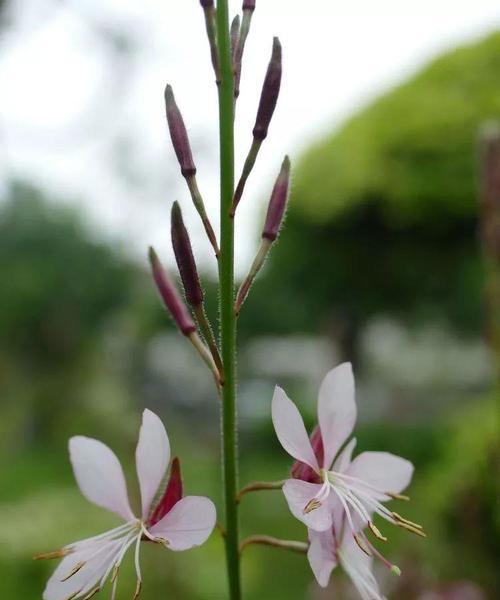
left=0, top=0, right=500, bottom=272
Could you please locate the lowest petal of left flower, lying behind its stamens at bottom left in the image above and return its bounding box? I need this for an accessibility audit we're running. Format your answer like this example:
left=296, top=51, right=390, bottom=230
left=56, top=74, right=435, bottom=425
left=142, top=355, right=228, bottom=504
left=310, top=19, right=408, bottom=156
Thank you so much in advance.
left=43, top=540, right=122, bottom=600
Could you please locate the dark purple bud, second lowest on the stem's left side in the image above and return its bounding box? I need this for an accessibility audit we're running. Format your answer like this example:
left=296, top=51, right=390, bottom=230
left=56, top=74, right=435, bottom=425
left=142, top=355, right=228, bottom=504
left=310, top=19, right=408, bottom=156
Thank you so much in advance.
left=171, top=202, right=203, bottom=306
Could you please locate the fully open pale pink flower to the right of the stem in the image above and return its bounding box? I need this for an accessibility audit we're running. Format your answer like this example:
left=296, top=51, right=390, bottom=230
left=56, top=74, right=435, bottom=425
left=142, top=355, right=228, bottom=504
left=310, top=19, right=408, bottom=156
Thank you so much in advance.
left=272, top=363, right=425, bottom=549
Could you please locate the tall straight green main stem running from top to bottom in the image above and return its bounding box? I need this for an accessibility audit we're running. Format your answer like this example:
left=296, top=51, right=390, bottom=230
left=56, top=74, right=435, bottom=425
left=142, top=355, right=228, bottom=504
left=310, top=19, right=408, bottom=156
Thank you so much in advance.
left=217, top=0, right=241, bottom=600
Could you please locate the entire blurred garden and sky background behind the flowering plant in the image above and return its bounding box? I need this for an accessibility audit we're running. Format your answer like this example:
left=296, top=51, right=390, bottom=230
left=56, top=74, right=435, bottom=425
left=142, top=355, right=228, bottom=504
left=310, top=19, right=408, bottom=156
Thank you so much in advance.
left=0, top=0, right=500, bottom=600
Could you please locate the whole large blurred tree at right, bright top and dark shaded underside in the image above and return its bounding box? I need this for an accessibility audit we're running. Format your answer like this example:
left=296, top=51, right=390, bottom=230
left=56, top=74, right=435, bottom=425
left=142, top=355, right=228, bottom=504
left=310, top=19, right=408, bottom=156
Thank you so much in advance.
left=241, top=33, right=500, bottom=341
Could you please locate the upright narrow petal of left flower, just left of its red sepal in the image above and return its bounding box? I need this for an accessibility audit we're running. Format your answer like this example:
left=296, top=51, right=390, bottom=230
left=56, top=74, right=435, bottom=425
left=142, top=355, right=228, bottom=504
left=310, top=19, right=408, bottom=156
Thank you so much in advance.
left=135, top=409, right=170, bottom=519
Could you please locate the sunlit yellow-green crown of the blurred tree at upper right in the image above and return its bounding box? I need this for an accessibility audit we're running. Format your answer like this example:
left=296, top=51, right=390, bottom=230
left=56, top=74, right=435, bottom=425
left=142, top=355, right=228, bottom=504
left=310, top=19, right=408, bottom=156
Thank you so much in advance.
left=293, top=33, right=500, bottom=223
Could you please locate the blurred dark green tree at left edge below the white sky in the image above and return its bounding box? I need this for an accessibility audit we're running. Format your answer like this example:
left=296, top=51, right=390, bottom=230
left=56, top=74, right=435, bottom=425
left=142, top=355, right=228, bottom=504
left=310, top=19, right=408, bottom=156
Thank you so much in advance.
left=0, top=184, right=133, bottom=365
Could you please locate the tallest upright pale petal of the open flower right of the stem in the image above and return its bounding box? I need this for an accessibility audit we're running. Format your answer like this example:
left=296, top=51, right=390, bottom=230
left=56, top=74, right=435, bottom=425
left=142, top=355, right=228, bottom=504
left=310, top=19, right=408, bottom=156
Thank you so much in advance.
left=318, top=363, right=356, bottom=469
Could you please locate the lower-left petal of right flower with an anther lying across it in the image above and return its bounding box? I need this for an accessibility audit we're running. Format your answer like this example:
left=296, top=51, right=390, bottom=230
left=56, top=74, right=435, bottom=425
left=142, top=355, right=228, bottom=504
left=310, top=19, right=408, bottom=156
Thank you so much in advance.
left=283, top=479, right=332, bottom=531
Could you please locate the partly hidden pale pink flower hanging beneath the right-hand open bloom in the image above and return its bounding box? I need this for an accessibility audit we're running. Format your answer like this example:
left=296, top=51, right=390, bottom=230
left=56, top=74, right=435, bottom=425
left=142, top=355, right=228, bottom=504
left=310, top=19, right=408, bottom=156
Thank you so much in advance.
left=307, top=528, right=390, bottom=600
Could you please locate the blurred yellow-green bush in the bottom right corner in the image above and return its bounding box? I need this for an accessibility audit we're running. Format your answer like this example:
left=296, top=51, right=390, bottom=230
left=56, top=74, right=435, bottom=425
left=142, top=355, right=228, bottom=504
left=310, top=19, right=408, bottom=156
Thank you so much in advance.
left=413, top=393, right=500, bottom=597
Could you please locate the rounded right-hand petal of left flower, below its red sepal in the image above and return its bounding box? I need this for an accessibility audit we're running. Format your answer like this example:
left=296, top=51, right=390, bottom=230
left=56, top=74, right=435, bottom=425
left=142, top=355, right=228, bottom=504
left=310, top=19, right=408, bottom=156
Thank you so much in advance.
left=149, top=496, right=216, bottom=551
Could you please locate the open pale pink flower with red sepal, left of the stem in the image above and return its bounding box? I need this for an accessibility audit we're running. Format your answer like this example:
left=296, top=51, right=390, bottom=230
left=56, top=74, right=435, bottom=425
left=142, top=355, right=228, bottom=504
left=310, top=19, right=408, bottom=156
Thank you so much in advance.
left=37, top=410, right=215, bottom=600
